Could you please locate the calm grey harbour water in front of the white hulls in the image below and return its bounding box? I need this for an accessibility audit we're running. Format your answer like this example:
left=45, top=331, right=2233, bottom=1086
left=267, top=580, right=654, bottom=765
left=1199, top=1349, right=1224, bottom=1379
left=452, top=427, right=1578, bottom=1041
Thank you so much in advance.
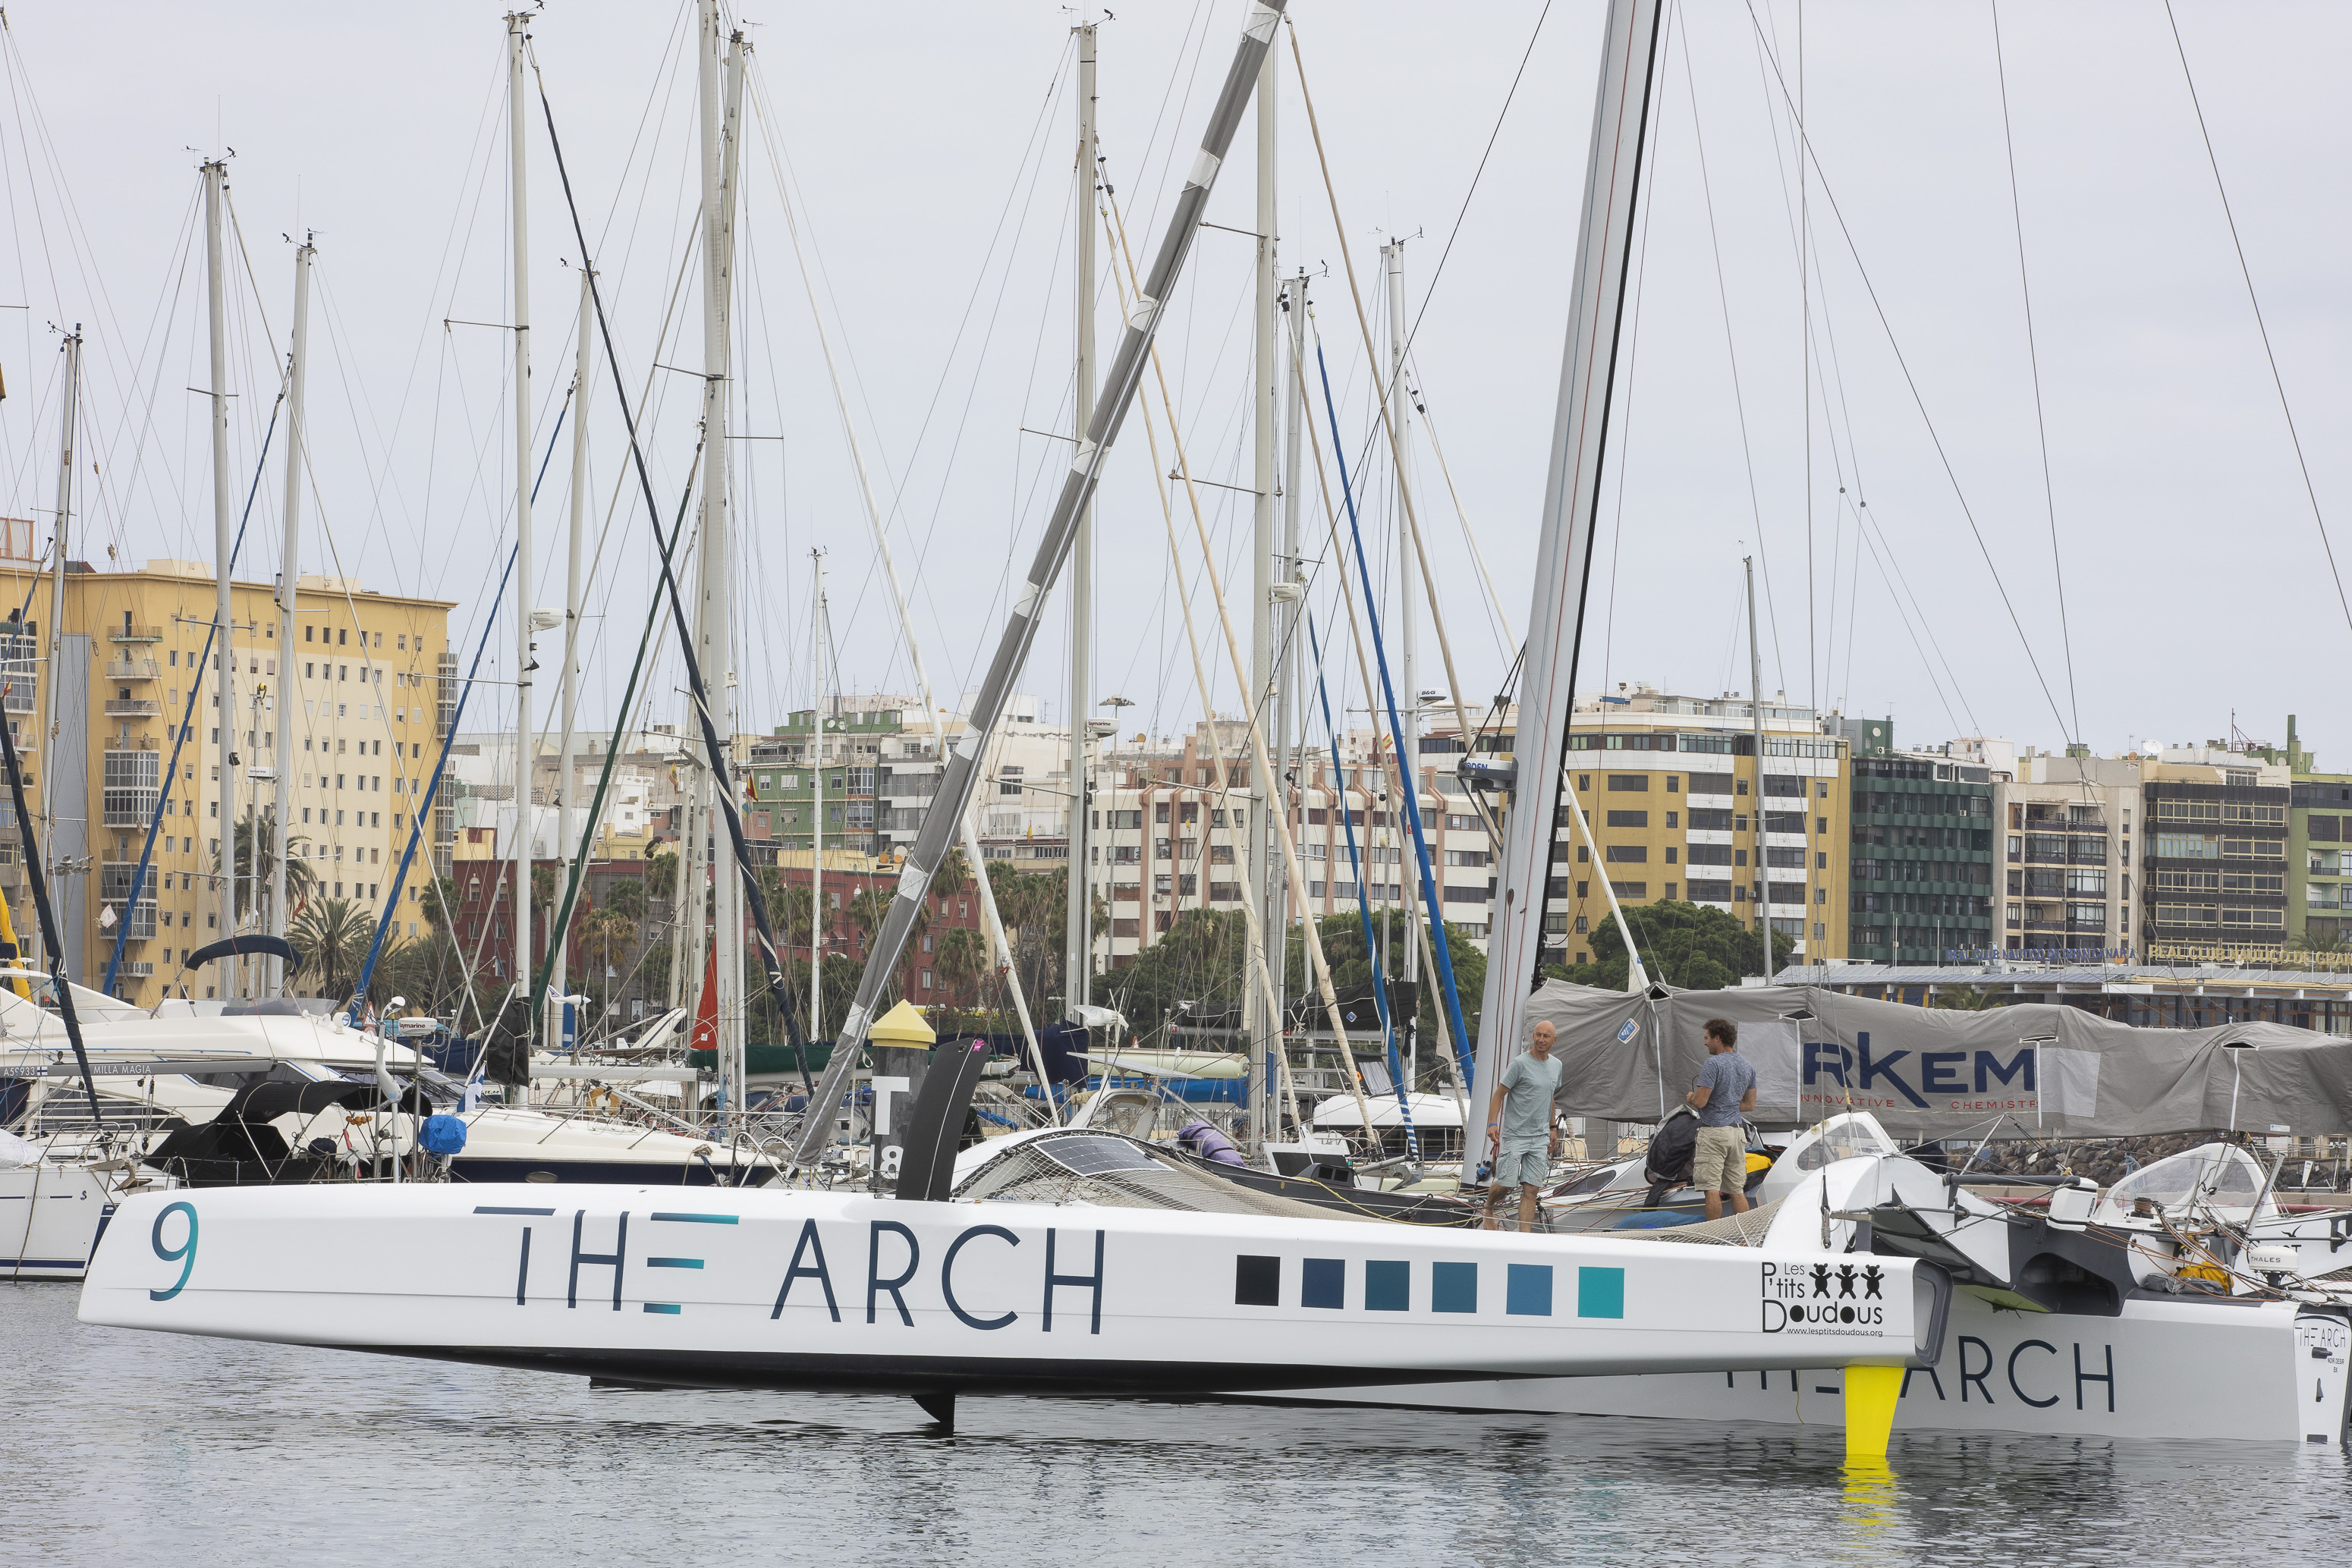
left=0, top=1286, right=2352, bottom=1568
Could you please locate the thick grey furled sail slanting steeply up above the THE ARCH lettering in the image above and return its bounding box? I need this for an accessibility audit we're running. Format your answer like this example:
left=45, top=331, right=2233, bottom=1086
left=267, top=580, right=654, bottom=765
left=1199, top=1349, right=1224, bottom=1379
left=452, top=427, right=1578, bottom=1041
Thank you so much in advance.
left=793, top=0, right=1287, bottom=1166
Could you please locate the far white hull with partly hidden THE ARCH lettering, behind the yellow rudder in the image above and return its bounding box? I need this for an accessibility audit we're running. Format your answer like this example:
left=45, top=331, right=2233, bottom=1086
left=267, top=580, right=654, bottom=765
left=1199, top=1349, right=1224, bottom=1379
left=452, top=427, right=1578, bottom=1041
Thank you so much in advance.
left=1300, top=1293, right=2352, bottom=1446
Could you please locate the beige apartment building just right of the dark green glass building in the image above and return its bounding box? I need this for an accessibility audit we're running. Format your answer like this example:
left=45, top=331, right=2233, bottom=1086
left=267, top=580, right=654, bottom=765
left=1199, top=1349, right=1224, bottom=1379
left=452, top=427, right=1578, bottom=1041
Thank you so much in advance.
left=1997, top=747, right=2147, bottom=964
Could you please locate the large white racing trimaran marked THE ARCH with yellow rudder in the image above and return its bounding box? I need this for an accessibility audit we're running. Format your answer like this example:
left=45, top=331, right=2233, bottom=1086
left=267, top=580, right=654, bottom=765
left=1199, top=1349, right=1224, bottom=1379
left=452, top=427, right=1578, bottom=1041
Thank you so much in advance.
left=83, top=0, right=2347, bottom=1455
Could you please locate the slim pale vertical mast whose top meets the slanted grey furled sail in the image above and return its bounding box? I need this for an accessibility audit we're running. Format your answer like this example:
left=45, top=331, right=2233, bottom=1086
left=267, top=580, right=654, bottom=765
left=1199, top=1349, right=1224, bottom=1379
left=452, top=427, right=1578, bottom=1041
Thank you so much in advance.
left=1241, top=33, right=1279, bottom=1147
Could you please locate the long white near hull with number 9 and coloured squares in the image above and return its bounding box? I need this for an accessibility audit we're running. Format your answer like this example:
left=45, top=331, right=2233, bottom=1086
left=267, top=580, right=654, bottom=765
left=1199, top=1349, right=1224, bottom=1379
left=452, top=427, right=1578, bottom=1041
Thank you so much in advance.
left=83, top=1185, right=1938, bottom=1394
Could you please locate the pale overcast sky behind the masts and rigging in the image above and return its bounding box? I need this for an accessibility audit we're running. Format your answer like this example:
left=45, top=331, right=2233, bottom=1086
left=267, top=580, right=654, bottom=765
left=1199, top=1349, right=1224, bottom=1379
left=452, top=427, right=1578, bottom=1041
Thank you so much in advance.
left=0, top=0, right=2352, bottom=766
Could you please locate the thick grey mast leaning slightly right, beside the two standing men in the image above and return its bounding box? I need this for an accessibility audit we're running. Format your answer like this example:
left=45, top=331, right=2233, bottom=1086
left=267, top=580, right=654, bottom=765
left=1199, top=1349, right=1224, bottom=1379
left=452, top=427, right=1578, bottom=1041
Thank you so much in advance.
left=1456, top=0, right=1661, bottom=1123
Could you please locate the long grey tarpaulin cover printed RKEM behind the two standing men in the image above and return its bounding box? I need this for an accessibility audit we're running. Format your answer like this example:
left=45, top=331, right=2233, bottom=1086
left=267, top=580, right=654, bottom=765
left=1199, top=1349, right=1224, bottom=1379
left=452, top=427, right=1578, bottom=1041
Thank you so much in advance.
left=1517, top=980, right=2352, bottom=1138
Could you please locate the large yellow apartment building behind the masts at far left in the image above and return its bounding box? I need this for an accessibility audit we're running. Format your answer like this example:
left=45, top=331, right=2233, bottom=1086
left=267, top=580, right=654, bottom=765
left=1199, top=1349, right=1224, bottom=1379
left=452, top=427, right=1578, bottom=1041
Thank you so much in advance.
left=0, top=555, right=456, bottom=1004
